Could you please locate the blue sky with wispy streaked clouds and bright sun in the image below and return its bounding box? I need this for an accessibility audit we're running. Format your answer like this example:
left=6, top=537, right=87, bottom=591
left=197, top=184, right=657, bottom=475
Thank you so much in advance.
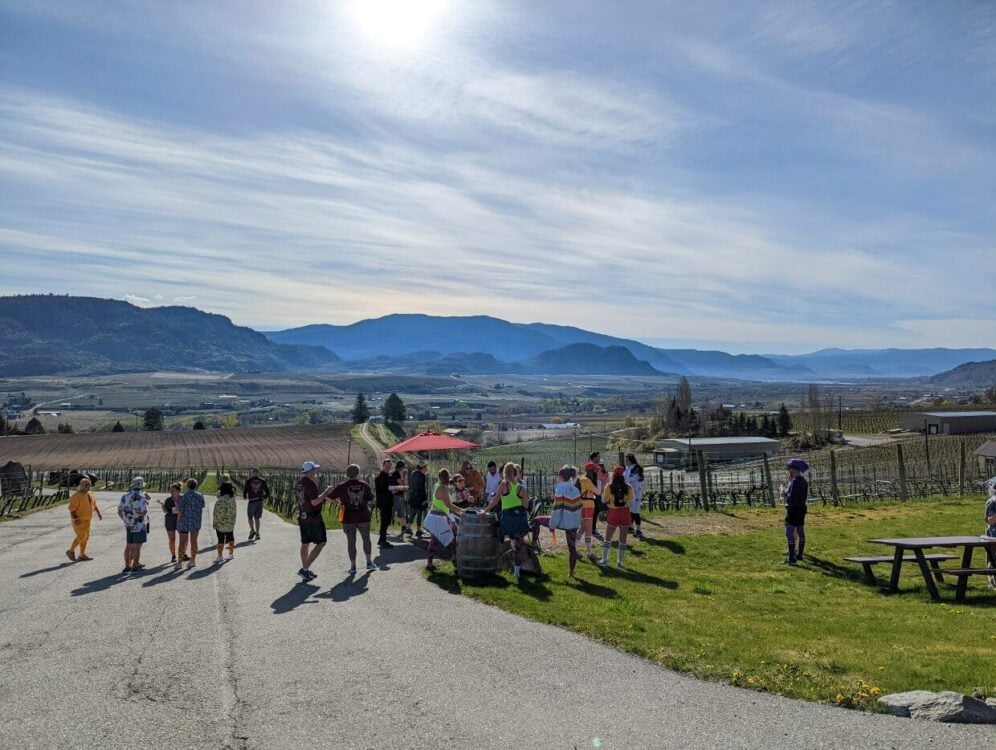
left=0, top=0, right=996, bottom=353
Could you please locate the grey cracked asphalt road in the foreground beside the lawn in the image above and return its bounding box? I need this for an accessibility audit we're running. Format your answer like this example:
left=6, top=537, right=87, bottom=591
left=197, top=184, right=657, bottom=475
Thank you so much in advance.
left=0, top=498, right=994, bottom=750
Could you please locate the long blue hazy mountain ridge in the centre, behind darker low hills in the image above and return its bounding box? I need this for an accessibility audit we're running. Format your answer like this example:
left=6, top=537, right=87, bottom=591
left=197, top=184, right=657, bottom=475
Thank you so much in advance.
left=266, top=314, right=792, bottom=380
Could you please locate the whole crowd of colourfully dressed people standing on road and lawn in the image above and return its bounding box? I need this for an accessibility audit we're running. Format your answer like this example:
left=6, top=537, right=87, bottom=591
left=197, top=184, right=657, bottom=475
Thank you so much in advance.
left=66, top=452, right=996, bottom=588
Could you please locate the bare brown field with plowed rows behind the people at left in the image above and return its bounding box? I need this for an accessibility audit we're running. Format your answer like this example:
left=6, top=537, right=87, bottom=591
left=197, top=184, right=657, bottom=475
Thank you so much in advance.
left=0, top=424, right=354, bottom=470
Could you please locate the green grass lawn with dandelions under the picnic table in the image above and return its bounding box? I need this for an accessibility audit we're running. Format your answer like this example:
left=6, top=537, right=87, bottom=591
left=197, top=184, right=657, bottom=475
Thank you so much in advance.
left=429, top=498, right=996, bottom=709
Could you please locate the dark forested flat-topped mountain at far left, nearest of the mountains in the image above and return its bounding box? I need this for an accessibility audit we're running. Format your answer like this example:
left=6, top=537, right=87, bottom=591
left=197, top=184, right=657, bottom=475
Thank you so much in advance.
left=0, top=295, right=339, bottom=376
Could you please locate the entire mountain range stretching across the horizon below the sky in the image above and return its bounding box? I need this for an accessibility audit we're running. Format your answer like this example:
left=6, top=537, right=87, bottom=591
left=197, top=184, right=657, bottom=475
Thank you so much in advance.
left=0, top=295, right=996, bottom=385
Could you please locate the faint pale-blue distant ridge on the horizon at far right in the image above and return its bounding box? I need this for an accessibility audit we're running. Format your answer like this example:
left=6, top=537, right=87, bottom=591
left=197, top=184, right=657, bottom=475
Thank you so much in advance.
left=765, top=349, right=996, bottom=378
